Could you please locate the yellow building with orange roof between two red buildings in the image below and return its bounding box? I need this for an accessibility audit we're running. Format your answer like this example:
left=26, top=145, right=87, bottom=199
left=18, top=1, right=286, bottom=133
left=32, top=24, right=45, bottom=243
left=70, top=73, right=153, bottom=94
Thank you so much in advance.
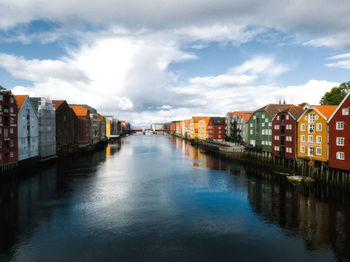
left=298, top=106, right=337, bottom=162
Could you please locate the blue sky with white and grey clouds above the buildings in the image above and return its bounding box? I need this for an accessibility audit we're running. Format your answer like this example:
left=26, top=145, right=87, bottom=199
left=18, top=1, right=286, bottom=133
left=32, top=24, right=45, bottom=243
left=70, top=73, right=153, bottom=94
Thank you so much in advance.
left=0, top=0, right=350, bottom=126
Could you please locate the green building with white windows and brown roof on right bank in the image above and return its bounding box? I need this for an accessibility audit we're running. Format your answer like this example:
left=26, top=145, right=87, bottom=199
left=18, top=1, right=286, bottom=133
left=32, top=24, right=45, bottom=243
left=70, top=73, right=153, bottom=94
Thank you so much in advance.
left=248, top=104, right=291, bottom=150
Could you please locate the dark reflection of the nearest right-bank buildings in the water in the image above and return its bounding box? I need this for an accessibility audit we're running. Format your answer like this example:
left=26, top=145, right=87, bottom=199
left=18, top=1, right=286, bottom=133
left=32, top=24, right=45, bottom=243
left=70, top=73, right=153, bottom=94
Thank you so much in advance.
left=248, top=176, right=350, bottom=261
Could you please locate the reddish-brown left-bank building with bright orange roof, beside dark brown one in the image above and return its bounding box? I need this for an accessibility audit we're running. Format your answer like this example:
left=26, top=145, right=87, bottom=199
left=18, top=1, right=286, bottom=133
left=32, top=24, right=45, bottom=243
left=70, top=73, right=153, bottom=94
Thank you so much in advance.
left=69, top=105, right=91, bottom=146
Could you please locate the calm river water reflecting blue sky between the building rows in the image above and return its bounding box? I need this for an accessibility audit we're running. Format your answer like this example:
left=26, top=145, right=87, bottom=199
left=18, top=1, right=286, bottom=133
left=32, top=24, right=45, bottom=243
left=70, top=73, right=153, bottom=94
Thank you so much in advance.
left=0, top=135, right=350, bottom=262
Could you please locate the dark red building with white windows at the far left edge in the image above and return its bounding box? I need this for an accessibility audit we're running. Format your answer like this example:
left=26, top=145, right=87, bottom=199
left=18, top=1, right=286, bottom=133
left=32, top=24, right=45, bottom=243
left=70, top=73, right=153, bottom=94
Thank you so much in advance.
left=0, top=91, right=18, bottom=169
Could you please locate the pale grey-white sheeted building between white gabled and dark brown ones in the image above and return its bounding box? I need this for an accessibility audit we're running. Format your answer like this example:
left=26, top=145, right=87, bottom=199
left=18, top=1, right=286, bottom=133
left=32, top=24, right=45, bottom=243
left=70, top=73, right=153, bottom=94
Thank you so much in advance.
left=30, top=97, right=56, bottom=158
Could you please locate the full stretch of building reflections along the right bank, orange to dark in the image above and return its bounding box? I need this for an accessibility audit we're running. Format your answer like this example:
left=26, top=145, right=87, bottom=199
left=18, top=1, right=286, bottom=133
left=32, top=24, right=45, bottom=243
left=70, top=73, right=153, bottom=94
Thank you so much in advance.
left=172, top=139, right=350, bottom=261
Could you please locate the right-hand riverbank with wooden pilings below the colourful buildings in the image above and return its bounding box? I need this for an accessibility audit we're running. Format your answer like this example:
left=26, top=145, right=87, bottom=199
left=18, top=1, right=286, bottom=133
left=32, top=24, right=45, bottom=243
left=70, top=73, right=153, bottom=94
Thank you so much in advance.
left=172, top=134, right=350, bottom=190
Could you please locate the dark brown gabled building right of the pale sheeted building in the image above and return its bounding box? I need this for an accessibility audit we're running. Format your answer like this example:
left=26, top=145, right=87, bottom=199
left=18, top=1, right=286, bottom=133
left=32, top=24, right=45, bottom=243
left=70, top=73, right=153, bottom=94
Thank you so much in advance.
left=52, top=100, right=78, bottom=154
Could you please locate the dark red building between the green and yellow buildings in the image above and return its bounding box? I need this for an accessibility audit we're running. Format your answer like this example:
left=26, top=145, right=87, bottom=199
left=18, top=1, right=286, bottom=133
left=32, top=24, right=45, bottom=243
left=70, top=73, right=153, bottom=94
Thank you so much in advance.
left=272, top=105, right=304, bottom=160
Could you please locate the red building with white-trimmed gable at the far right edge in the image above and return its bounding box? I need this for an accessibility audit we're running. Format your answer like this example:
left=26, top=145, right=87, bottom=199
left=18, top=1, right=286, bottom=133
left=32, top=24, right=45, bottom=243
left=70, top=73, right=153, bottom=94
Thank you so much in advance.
left=328, top=93, right=350, bottom=171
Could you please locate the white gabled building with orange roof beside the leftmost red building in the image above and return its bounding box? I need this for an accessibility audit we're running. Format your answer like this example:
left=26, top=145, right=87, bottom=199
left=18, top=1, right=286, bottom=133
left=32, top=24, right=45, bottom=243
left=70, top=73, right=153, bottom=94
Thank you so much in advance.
left=15, top=95, right=39, bottom=161
